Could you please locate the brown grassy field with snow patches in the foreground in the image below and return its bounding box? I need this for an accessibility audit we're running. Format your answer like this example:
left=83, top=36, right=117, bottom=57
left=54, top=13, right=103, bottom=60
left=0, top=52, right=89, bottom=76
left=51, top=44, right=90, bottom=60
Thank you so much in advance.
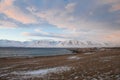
left=0, top=48, right=120, bottom=80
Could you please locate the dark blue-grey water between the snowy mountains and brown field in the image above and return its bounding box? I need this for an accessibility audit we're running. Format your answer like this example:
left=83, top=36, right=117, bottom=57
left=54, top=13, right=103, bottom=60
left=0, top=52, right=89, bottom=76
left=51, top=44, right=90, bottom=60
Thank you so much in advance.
left=0, top=48, right=72, bottom=57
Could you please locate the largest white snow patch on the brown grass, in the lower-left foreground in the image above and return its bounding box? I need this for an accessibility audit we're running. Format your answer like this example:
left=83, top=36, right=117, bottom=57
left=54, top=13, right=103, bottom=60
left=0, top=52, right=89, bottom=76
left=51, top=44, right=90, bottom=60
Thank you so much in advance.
left=11, top=66, right=71, bottom=77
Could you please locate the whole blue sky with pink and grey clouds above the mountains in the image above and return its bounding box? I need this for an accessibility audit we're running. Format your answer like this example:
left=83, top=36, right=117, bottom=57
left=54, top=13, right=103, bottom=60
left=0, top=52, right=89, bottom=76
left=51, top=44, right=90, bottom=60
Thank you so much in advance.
left=0, top=0, right=120, bottom=43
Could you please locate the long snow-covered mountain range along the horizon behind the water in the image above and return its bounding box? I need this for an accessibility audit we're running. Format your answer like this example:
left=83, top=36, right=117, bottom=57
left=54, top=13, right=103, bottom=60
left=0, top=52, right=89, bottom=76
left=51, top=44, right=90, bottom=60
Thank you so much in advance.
left=0, top=40, right=118, bottom=47
